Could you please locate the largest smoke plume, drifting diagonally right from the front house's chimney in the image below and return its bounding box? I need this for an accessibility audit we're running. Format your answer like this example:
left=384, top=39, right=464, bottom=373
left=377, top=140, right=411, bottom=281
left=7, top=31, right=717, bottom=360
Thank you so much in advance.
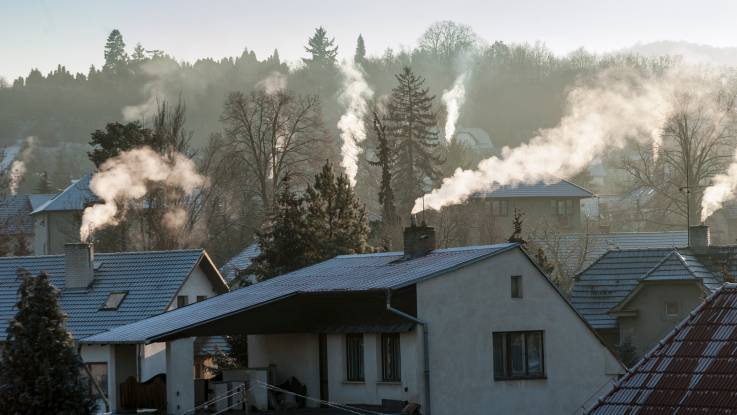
left=412, top=68, right=703, bottom=213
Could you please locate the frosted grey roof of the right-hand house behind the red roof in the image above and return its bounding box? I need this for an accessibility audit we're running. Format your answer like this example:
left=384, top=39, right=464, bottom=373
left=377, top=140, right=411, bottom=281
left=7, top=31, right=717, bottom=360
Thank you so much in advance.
left=571, top=248, right=721, bottom=329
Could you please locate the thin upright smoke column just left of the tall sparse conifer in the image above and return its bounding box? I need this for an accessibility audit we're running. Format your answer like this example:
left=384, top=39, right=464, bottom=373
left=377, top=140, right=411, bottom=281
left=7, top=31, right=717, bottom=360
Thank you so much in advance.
left=338, top=61, right=374, bottom=186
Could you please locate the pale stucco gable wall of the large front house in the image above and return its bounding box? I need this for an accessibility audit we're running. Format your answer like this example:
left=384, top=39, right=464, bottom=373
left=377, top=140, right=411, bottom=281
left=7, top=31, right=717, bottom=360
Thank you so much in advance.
left=417, top=250, right=622, bottom=415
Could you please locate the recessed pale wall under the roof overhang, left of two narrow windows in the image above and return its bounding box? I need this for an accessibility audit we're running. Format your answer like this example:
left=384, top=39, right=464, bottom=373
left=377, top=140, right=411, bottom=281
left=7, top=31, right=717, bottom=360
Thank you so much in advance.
left=248, top=334, right=320, bottom=406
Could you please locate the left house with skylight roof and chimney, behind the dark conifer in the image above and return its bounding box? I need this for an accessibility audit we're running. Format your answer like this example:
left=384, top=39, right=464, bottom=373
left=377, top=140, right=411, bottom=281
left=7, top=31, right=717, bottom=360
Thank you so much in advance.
left=0, top=244, right=228, bottom=408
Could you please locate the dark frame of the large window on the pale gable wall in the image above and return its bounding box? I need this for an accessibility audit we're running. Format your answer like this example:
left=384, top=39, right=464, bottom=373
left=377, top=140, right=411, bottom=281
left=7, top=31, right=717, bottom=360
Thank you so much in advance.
left=492, top=330, right=547, bottom=381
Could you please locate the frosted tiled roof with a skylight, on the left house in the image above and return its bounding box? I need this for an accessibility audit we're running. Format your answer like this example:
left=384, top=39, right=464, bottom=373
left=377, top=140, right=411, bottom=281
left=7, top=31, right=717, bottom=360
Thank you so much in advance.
left=0, top=249, right=227, bottom=339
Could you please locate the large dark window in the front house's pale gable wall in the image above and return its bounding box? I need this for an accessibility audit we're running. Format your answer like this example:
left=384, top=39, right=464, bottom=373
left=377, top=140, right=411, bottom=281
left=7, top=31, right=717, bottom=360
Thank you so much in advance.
left=493, top=331, right=545, bottom=380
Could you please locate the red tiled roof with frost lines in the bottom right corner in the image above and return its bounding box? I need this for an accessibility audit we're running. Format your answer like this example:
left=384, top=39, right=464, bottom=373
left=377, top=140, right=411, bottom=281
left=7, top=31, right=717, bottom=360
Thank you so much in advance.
left=589, top=284, right=737, bottom=415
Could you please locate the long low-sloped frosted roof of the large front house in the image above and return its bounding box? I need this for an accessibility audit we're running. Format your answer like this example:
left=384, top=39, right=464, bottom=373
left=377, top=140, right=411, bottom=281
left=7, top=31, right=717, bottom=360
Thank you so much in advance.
left=85, top=244, right=518, bottom=343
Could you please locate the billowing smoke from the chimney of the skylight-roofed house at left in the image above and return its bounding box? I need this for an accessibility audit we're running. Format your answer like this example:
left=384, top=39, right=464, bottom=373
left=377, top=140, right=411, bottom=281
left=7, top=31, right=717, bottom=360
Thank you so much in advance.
left=79, top=147, right=206, bottom=241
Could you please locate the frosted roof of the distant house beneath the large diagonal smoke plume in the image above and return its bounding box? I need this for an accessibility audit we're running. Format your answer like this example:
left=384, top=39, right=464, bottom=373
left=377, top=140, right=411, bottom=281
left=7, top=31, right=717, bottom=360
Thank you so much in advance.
left=473, top=179, right=594, bottom=199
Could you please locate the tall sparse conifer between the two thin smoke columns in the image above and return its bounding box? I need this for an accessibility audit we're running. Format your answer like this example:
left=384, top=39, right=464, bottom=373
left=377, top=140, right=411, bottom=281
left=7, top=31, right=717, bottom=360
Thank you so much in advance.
left=388, top=67, right=442, bottom=217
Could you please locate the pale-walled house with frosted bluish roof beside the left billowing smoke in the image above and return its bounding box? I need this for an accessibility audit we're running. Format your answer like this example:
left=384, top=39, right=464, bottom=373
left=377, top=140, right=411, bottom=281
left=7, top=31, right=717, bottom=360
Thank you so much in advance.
left=31, top=175, right=98, bottom=255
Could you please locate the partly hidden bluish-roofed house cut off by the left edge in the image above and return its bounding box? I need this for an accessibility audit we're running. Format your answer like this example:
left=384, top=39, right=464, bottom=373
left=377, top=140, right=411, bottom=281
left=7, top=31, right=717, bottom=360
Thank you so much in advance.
left=0, top=194, right=54, bottom=253
